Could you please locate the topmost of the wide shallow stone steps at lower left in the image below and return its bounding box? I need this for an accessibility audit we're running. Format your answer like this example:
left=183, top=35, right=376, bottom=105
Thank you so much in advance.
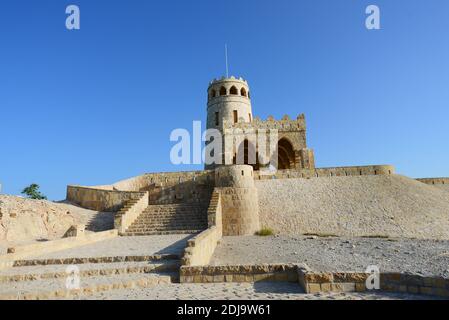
left=10, top=254, right=180, bottom=268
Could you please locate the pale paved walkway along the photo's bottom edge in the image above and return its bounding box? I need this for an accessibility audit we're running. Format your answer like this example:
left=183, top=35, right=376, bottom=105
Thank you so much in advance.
left=87, top=282, right=435, bottom=300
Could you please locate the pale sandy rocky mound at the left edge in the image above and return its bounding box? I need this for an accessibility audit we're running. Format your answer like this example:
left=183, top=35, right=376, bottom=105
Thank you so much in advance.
left=0, top=195, right=113, bottom=254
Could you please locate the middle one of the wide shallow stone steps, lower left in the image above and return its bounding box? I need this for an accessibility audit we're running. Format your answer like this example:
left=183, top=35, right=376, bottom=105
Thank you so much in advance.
left=0, top=260, right=180, bottom=284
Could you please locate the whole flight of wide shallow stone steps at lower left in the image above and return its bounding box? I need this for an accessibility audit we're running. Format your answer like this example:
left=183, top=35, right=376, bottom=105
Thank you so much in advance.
left=0, top=254, right=179, bottom=300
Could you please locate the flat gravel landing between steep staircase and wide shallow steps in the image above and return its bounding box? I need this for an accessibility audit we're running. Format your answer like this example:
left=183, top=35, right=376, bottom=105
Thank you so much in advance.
left=28, top=234, right=193, bottom=259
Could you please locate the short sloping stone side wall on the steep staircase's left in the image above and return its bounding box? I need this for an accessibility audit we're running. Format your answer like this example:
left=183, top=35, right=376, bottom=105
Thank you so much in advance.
left=114, top=192, right=149, bottom=234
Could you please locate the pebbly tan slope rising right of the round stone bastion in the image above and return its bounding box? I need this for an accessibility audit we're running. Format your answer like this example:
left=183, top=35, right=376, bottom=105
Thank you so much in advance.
left=256, top=175, right=449, bottom=239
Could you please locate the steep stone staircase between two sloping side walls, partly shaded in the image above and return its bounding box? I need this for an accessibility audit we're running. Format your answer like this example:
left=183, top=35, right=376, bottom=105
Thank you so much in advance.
left=124, top=202, right=209, bottom=236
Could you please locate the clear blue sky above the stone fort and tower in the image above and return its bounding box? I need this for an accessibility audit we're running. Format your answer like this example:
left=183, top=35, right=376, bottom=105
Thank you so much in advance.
left=0, top=0, right=449, bottom=200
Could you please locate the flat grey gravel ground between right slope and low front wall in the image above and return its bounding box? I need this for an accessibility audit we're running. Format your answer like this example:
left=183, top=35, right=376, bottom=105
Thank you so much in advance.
left=211, top=236, right=449, bottom=277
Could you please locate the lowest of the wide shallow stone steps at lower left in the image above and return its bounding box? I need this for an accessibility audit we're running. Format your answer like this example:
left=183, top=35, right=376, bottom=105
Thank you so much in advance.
left=0, top=273, right=178, bottom=300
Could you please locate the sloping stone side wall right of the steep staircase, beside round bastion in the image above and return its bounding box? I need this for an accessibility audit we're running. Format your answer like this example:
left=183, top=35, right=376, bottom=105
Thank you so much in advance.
left=181, top=191, right=222, bottom=273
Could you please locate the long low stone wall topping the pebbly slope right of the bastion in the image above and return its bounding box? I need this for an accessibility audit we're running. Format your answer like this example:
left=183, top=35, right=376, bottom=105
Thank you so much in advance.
left=254, top=165, right=395, bottom=180
